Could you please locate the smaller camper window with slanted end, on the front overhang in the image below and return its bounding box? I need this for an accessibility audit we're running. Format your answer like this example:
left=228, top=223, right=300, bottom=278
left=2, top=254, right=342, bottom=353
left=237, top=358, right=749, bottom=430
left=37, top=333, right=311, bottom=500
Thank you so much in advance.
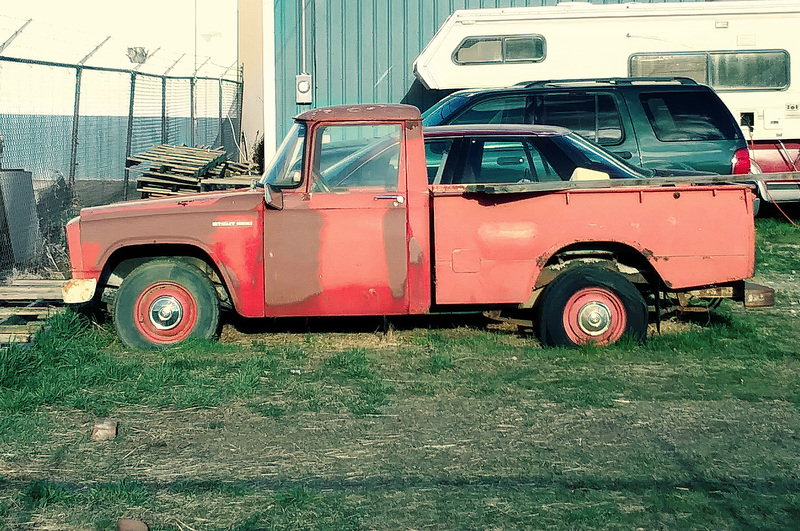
left=453, top=35, right=546, bottom=65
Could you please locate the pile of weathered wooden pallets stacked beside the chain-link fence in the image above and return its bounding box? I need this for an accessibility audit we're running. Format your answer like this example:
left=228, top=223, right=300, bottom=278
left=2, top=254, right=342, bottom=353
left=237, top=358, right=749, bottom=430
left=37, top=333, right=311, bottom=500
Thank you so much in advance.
left=126, top=144, right=255, bottom=197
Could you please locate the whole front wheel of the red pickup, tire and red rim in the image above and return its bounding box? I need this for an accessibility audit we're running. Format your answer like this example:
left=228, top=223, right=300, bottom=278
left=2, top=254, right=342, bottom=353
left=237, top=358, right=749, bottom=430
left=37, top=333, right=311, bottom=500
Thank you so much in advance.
left=112, top=260, right=219, bottom=349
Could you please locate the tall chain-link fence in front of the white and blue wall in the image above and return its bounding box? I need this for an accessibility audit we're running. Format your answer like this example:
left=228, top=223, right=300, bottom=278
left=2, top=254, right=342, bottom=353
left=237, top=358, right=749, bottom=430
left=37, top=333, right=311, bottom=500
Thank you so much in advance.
left=0, top=56, right=242, bottom=278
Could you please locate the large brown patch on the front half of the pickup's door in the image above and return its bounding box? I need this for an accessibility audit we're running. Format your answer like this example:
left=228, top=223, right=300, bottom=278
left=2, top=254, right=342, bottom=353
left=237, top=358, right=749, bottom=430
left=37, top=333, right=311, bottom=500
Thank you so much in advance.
left=264, top=209, right=324, bottom=306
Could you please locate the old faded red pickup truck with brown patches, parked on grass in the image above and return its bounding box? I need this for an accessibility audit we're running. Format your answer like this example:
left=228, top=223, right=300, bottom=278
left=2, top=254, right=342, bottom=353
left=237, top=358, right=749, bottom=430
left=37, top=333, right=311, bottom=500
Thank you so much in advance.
left=64, top=105, right=771, bottom=348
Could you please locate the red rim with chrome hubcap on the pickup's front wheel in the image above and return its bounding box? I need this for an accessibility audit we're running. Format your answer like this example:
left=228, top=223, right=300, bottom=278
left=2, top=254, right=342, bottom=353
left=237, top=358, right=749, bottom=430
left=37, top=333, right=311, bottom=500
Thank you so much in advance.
left=134, top=282, right=197, bottom=344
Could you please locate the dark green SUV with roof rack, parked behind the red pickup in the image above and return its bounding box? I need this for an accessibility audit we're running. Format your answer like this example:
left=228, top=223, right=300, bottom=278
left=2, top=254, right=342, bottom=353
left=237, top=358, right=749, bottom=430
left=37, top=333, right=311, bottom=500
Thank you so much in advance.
left=423, top=78, right=750, bottom=175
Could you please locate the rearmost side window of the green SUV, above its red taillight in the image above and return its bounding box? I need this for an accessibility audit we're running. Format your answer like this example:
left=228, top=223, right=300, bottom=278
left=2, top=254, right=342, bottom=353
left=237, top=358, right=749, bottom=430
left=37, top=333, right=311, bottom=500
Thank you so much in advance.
left=639, top=92, right=737, bottom=142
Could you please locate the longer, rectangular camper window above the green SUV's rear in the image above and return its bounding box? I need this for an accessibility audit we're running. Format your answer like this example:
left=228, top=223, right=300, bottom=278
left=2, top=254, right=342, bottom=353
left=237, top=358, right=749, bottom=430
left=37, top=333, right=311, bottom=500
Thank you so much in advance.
left=628, top=50, right=789, bottom=90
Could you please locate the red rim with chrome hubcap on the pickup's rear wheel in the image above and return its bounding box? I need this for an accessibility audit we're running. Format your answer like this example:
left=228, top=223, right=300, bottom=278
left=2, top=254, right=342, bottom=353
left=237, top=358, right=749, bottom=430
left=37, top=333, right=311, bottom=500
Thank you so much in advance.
left=564, top=287, right=627, bottom=345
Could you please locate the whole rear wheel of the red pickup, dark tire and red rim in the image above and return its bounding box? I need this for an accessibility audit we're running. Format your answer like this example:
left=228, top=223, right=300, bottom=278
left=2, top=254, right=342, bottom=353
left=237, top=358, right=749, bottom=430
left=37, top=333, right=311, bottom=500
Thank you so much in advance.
left=537, top=266, right=647, bottom=347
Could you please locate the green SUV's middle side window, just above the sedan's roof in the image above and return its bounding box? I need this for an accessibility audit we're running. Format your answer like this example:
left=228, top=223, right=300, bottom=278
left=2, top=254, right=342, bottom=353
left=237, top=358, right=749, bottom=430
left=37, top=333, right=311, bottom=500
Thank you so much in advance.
left=533, top=92, right=624, bottom=146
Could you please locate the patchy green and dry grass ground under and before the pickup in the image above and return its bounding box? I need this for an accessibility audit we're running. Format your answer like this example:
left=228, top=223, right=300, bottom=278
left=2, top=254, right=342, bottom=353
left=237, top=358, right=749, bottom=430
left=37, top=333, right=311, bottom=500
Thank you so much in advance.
left=0, top=219, right=800, bottom=531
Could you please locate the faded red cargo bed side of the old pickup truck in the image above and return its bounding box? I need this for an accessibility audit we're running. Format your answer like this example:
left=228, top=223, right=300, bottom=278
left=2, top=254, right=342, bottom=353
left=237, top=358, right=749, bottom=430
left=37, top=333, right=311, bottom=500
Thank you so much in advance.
left=430, top=181, right=754, bottom=305
